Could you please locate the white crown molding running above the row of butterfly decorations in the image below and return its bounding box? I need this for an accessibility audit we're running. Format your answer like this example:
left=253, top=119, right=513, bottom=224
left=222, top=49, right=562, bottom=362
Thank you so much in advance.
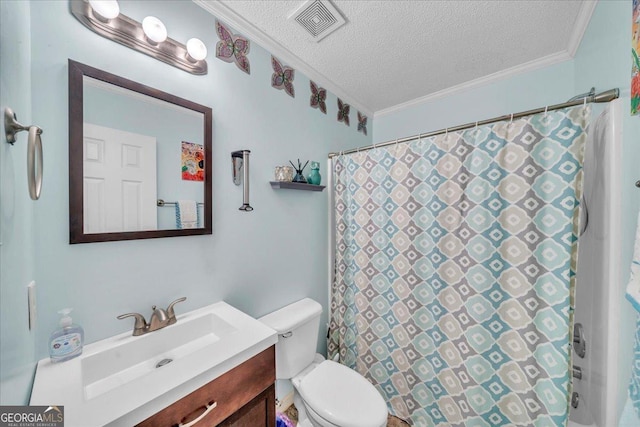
left=192, top=0, right=373, bottom=118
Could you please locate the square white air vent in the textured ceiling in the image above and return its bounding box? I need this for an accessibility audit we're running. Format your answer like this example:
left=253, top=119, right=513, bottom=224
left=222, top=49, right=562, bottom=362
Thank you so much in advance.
left=289, top=0, right=346, bottom=42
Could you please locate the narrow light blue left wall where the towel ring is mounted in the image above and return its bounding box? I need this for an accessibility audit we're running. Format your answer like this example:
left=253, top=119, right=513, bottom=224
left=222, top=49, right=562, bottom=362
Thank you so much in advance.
left=0, top=1, right=36, bottom=405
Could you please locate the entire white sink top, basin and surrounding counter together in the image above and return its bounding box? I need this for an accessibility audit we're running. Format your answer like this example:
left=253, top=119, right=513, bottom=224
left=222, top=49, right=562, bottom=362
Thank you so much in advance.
left=30, top=302, right=277, bottom=427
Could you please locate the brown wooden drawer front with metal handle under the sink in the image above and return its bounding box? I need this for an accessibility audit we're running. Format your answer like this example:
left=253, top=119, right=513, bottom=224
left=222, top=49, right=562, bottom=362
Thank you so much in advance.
left=138, top=346, right=276, bottom=427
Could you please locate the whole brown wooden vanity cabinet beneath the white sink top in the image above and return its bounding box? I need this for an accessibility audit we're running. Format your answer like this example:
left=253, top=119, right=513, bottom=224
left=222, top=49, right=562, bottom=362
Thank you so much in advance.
left=136, top=346, right=276, bottom=427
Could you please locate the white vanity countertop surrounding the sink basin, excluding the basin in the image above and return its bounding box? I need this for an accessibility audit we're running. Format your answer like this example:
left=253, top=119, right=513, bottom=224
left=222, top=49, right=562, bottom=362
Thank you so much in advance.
left=30, top=302, right=278, bottom=427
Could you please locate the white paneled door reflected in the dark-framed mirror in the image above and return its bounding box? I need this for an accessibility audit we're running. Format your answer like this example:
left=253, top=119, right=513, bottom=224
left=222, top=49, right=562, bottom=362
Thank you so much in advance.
left=83, top=123, right=158, bottom=233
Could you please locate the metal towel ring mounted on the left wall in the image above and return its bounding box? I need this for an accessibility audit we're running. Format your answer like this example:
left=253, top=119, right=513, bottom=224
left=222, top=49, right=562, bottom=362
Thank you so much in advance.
left=4, top=108, right=42, bottom=200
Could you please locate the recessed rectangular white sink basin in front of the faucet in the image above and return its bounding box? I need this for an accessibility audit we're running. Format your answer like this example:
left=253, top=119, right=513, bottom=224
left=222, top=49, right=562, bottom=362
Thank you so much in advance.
left=80, top=313, right=237, bottom=399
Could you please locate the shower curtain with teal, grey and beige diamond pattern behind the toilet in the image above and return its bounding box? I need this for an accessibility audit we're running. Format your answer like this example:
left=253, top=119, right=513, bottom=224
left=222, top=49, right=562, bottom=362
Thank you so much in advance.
left=328, top=106, right=590, bottom=427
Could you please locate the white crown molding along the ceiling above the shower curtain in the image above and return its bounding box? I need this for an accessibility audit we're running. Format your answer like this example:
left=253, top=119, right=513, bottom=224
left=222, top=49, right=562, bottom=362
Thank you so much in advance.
left=374, top=50, right=573, bottom=119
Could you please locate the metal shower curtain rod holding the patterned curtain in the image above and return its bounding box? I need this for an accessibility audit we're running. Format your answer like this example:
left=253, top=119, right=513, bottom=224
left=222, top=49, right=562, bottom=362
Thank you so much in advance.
left=329, top=88, right=616, bottom=159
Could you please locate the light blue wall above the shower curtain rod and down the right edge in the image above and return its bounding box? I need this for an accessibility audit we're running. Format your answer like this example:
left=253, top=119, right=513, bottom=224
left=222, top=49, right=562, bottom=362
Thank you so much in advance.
left=373, top=1, right=640, bottom=422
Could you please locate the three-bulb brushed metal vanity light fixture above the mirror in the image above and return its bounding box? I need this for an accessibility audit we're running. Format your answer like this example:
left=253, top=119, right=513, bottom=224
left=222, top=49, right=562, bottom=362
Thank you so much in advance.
left=69, top=0, right=207, bottom=75
